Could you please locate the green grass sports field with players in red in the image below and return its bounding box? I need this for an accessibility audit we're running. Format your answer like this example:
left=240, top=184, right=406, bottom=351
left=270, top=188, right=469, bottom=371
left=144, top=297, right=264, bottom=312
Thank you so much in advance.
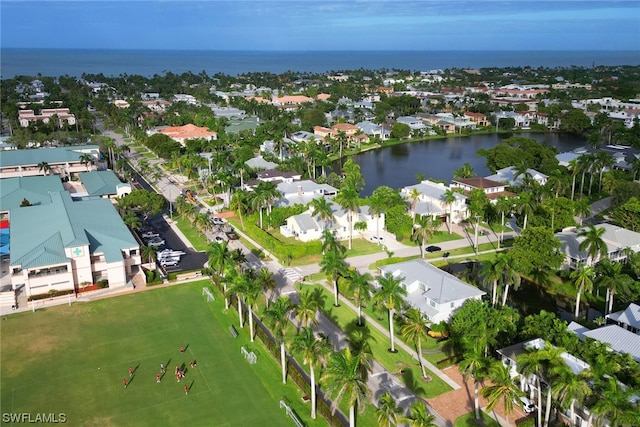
left=0, top=281, right=302, bottom=426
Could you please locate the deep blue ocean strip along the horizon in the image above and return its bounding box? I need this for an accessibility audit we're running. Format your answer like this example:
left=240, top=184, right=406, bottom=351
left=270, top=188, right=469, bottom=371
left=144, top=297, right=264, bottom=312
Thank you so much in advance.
left=0, top=48, right=640, bottom=79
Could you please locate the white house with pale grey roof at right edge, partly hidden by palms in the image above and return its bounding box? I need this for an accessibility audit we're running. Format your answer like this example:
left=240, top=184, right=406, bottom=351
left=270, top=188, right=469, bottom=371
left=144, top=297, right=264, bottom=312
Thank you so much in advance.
left=555, top=223, right=640, bottom=270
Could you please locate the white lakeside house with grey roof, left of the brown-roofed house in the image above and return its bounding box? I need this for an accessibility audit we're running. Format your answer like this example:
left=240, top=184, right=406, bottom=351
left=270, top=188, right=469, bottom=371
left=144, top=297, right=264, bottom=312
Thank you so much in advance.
left=400, top=180, right=469, bottom=224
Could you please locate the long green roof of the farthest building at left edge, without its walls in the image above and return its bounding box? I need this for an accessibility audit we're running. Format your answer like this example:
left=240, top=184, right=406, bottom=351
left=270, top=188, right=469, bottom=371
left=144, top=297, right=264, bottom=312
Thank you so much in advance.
left=0, top=145, right=100, bottom=167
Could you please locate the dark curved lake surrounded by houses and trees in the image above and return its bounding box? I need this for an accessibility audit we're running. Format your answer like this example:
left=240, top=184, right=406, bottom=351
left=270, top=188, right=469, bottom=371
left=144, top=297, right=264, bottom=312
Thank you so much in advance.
left=344, top=133, right=586, bottom=197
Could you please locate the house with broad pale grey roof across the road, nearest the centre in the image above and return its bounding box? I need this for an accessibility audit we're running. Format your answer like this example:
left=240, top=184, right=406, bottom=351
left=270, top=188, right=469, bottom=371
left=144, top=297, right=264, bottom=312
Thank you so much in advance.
left=379, top=259, right=485, bottom=323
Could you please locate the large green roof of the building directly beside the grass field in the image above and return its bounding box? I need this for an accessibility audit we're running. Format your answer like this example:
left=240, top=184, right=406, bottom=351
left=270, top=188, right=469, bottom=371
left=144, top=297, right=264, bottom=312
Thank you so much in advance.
left=9, top=191, right=139, bottom=268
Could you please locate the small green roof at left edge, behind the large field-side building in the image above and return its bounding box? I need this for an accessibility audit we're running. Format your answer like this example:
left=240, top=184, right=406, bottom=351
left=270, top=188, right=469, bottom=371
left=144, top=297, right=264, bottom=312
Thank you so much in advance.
left=0, top=175, right=64, bottom=211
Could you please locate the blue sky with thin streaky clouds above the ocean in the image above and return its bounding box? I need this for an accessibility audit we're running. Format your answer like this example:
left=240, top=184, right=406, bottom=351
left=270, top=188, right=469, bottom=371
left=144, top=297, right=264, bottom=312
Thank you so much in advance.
left=0, top=0, right=640, bottom=51
